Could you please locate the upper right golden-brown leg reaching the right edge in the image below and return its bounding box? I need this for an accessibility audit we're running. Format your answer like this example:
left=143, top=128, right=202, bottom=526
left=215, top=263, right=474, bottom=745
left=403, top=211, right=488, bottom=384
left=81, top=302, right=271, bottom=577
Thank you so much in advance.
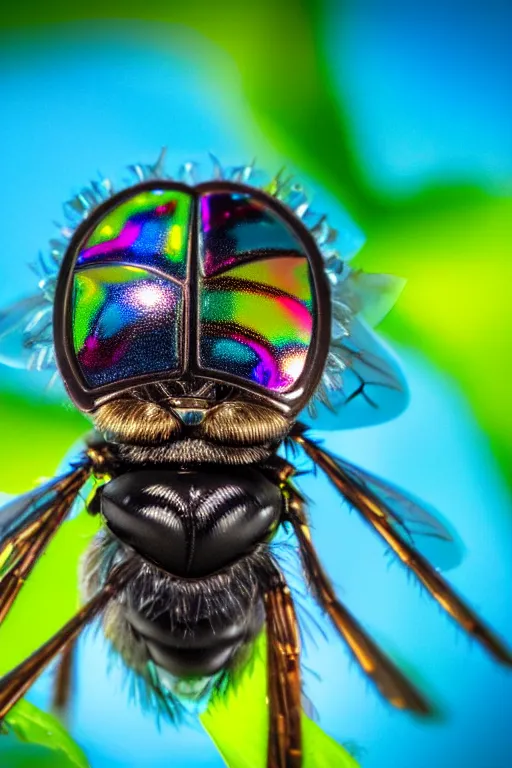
left=293, top=433, right=512, bottom=666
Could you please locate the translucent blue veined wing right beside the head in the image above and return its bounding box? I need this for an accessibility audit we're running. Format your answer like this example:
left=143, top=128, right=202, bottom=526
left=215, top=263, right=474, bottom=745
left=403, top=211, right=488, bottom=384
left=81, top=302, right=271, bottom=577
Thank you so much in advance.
left=300, top=318, right=409, bottom=430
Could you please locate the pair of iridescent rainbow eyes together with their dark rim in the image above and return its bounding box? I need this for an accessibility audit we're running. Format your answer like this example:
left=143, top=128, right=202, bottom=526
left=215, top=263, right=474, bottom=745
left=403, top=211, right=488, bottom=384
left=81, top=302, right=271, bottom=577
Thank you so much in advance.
left=56, top=181, right=330, bottom=410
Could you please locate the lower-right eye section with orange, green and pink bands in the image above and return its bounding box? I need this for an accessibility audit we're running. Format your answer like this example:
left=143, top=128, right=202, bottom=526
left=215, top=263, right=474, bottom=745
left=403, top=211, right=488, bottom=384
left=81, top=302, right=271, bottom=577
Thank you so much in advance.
left=200, top=257, right=313, bottom=392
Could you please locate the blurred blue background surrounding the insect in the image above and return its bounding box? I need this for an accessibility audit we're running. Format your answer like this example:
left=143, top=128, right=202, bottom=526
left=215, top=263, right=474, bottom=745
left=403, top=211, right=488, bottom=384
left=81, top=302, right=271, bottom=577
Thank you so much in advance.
left=0, top=2, right=512, bottom=768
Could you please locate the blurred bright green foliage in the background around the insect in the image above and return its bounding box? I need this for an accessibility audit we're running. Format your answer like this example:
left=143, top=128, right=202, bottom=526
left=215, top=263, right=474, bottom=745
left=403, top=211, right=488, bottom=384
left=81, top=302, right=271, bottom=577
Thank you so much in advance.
left=0, top=0, right=506, bottom=768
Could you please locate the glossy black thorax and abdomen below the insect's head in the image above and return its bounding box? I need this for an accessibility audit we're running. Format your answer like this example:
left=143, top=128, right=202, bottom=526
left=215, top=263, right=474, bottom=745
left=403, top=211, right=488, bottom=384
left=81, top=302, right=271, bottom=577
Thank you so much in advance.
left=97, top=466, right=284, bottom=677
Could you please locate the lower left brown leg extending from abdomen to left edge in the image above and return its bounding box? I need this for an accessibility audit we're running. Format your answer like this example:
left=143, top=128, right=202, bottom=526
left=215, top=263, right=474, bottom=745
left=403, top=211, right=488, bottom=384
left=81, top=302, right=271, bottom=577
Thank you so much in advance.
left=0, top=562, right=133, bottom=722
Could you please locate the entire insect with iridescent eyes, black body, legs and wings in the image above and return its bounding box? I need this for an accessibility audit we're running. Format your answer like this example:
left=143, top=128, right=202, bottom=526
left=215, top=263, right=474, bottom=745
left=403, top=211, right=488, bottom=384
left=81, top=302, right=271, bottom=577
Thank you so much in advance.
left=0, top=158, right=512, bottom=768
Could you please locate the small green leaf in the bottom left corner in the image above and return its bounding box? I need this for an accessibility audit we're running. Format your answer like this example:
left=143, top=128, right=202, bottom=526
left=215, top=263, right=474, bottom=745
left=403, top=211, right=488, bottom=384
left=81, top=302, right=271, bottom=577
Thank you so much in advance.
left=0, top=700, right=89, bottom=768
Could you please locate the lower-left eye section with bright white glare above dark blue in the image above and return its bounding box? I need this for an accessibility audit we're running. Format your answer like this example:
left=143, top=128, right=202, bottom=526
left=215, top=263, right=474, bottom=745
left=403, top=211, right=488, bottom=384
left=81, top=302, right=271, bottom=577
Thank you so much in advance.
left=72, top=265, right=183, bottom=388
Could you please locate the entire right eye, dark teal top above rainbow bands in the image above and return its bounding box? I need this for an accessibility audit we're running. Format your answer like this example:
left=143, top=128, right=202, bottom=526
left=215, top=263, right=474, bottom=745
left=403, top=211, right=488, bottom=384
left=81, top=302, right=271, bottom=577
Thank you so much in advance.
left=199, top=191, right=314, bottom=393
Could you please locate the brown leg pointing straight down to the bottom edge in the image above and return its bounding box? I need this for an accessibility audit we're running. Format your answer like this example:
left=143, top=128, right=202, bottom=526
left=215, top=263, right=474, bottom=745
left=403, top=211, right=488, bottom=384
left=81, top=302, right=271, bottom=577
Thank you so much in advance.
left=265, top=569, right=302, bottom=768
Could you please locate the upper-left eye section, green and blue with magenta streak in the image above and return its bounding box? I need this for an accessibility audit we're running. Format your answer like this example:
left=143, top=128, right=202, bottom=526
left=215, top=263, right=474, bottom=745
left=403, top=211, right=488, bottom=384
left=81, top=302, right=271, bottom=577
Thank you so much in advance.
left=76, top=189, right=192, bottom=279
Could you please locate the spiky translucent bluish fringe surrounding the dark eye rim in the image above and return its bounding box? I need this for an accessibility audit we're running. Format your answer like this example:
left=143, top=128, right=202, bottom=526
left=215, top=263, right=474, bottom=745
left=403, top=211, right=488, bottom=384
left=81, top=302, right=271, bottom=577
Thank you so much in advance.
left=0, top=149, right=405, bottom=428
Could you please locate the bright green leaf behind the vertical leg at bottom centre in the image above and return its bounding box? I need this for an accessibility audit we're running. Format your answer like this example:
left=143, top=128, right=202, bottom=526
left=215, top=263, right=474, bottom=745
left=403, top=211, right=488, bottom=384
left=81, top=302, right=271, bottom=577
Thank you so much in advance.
left=201, top=634, right=358, bottom=768
